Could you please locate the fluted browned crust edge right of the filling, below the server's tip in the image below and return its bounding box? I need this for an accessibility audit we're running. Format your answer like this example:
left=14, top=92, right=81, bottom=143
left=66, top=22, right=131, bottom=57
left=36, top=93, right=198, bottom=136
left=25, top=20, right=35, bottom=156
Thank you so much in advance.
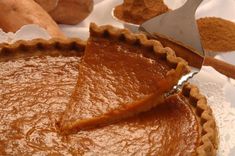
left=181, top=83, right=218, bottom=156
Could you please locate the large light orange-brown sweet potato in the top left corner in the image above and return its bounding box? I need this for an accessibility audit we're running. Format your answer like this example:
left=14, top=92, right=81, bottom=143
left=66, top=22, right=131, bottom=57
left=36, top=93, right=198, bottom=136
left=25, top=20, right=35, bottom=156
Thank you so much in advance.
left=0, top=0, right=64, bottom=37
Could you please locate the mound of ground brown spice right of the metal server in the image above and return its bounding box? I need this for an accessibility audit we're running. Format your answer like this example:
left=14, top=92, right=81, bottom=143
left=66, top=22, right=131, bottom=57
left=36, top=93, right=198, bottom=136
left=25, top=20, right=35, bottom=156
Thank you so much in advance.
left=197, top=17, right=235, bottom=52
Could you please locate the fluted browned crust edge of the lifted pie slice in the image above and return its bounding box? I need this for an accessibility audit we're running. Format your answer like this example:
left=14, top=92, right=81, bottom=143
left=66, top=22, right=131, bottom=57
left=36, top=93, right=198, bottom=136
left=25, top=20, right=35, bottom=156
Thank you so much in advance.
left=90, top=23, right=189, bottom=77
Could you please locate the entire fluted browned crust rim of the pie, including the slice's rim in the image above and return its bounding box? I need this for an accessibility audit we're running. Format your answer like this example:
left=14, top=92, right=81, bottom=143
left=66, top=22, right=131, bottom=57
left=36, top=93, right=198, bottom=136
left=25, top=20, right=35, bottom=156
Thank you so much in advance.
left=0, top=24, right=218, bottom=156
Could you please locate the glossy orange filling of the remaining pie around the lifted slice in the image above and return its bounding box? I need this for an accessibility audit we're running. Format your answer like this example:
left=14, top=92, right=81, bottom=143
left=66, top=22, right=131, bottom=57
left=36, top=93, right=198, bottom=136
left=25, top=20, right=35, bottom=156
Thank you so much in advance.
left=0, top=57, right=199, bottom=155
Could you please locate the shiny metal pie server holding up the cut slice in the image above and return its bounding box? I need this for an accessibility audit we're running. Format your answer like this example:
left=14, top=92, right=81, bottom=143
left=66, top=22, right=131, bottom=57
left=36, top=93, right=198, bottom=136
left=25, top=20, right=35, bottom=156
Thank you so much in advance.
left=139, top=0, right=204, bottom=91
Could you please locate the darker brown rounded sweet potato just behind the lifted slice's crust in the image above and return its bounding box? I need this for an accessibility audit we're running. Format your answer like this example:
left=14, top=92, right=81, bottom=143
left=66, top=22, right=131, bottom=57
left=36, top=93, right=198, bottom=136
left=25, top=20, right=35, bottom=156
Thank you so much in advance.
left=49, top=0, right=94, bottom=24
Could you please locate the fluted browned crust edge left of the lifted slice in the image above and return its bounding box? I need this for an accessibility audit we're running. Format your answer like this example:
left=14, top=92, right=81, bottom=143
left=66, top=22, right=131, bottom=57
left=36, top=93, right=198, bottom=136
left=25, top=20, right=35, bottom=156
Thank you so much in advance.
left=0, top=38, right=86, bottom=61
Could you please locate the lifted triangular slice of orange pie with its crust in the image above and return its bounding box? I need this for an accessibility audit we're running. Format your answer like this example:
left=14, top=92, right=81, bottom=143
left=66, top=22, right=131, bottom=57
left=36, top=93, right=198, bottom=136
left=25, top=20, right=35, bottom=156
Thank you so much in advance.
left=59, top=24, right=188, bottom=134
